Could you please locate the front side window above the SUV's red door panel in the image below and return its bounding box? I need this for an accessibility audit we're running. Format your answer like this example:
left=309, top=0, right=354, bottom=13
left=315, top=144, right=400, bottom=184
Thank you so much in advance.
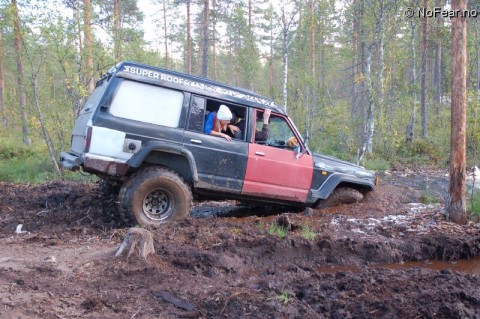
left=256, top=112, right=298, bottom=149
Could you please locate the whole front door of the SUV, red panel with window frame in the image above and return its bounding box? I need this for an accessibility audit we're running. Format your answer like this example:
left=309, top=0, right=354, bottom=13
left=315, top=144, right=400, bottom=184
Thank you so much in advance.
left=242, top=110, right=313, bottom=202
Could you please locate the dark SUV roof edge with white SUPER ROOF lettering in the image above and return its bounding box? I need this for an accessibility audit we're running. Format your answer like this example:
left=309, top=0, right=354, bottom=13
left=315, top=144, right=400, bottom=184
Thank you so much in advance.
left=109, top=61, right=286, bottom=115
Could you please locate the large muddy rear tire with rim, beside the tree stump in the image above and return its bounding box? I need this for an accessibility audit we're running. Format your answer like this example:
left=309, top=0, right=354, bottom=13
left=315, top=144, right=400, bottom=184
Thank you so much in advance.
left=118, top=167, right=192, bottom=227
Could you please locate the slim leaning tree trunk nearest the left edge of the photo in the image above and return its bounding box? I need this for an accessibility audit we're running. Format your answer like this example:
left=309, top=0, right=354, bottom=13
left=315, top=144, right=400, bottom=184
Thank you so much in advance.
left=12, top=0, right=32, bottom=145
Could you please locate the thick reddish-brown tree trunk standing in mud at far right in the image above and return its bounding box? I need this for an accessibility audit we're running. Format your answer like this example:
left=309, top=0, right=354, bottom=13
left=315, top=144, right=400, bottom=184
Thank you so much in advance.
left=447, top=0, right=467, bottom=224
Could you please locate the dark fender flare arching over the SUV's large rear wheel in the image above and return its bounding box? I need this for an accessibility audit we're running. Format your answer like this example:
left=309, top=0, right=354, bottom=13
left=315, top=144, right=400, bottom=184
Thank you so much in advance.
left=127, top=141, right=198, bottom=182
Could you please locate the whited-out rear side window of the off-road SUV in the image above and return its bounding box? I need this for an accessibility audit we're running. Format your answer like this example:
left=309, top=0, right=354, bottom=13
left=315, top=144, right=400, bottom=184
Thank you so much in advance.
left=110, top=80, right=183, bottom=127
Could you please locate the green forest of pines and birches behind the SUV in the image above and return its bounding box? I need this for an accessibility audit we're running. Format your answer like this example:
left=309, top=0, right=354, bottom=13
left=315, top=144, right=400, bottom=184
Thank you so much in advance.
left=0, top=0, right=480, bottom=182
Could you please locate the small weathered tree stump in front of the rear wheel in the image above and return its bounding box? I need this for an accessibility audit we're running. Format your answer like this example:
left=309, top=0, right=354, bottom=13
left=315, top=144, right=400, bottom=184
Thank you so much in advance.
left=115, top=227, right=155, bottom=260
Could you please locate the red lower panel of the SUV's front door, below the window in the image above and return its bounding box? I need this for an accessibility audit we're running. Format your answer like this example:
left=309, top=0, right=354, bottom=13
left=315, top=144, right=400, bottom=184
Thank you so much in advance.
left=242, top=143, right=313, bottom=202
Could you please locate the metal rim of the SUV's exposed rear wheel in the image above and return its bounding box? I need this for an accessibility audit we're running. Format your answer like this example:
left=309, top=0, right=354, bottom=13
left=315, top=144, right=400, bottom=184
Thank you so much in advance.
left=143, top=188, right=175, bottom=221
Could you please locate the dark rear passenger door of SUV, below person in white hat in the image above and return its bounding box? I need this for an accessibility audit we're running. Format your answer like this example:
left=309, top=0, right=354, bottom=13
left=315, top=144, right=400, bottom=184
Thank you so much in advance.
left=183, top=95, right=248, bottom=193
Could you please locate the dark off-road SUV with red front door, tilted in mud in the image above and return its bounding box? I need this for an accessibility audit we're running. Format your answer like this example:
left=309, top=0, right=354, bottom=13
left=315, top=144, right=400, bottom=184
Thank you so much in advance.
left=60, top=62, right=377, bottom=225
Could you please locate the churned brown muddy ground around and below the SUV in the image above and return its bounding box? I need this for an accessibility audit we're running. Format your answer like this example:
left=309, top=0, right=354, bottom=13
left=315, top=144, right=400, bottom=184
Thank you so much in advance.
left=0, top=171, right=480, bottom=318
